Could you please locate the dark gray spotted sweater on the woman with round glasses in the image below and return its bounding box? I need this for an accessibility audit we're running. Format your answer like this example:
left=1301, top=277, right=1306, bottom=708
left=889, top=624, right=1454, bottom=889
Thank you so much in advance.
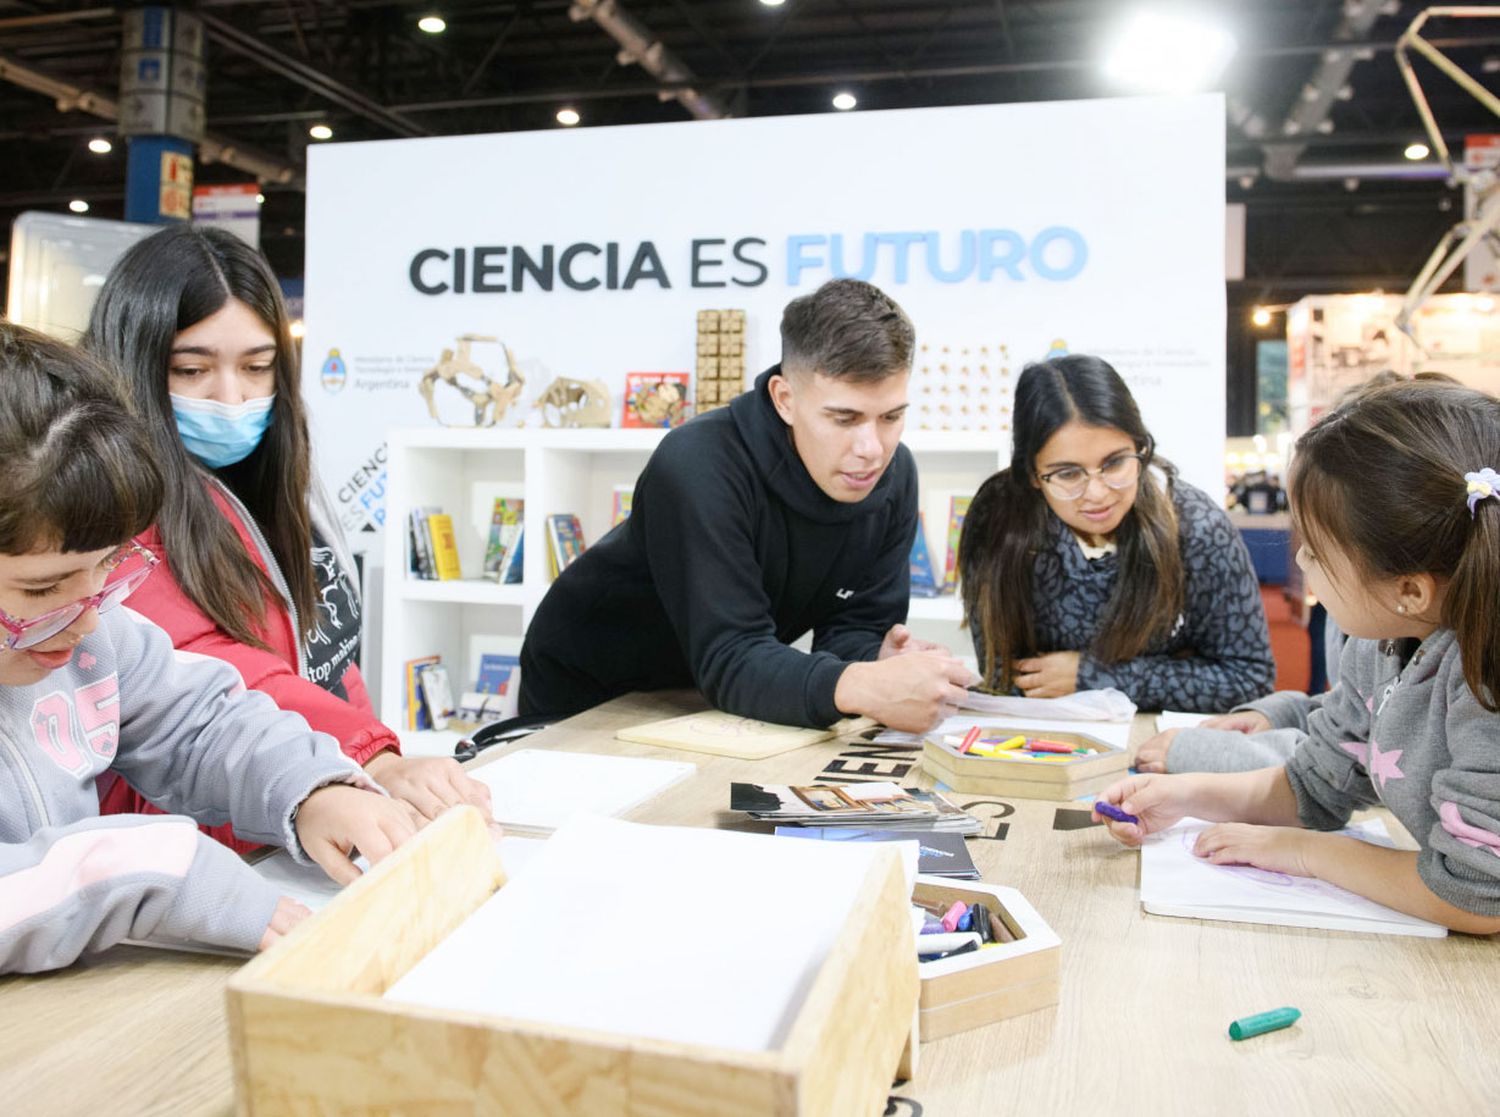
left=975, top=480, right=1277, bottom=712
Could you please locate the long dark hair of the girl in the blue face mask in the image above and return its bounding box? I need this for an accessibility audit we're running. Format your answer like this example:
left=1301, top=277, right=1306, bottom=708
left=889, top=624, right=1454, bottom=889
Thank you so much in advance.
left=81, top=225, right=314, bottom=648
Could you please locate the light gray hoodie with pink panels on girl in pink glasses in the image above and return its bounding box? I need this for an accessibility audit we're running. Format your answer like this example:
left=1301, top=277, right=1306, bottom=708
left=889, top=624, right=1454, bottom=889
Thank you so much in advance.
left=0, top=607, right=380, bottom=973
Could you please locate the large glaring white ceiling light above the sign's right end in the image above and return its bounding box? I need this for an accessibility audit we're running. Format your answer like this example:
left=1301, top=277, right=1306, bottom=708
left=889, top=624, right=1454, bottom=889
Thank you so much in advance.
left=1104, top=12, right=1235, bottom=93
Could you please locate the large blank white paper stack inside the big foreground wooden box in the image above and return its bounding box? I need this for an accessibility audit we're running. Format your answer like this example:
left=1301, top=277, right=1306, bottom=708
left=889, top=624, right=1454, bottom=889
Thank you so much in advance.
left=386, top=817, right=917, bottom=1051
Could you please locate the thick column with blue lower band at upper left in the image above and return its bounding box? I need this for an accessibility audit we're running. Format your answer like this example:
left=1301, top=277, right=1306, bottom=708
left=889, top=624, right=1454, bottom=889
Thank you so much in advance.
left=119, top=6, right=207, bottom=223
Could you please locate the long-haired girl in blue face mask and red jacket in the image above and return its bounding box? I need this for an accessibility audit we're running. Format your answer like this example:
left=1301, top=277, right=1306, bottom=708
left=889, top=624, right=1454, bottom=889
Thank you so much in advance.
left=81, top=225, right=489, bottom=847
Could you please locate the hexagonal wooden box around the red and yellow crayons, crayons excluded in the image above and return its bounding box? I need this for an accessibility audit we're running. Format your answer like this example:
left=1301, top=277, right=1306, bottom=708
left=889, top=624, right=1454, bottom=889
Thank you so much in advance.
left=923, top=726, right=1128, bottom=799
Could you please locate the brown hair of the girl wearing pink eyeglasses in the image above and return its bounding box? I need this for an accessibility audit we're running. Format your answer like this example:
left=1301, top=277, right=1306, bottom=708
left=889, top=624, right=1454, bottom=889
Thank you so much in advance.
left=0, top=321, right=162, bottom=555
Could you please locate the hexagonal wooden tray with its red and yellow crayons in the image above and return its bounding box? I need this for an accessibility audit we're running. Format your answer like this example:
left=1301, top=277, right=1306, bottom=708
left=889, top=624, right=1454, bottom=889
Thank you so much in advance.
left=923, top=726, right=1127, bottom=799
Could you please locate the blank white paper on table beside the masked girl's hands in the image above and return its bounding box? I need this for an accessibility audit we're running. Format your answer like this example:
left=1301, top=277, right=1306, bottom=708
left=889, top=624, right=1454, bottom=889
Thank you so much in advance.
left=468, top=748, right=698, bottom=831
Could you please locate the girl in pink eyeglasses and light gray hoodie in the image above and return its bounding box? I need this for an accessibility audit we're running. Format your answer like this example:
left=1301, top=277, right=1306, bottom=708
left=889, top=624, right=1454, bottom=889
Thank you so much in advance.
left=0, top=321, right=417, bottom=973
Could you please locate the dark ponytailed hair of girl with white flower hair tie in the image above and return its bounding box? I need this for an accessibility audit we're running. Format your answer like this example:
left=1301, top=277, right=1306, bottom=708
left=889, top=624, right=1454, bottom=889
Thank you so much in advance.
left=1289, top=378, right=1500, bottom=712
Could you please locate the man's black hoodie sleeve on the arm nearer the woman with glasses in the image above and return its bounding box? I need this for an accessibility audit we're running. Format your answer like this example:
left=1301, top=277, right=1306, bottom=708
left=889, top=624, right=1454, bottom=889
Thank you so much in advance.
left=813, top=445, right=917, bottom=661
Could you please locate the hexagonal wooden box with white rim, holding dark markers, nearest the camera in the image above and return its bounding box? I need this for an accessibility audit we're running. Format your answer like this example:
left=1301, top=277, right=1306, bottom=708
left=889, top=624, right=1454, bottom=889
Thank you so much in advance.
left=912, top=876, right=1062, bottom=1041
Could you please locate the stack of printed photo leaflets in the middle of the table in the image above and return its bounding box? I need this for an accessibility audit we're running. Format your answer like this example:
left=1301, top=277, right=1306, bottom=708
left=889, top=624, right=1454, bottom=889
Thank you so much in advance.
left=729, top=783, right=984, bottom=834
